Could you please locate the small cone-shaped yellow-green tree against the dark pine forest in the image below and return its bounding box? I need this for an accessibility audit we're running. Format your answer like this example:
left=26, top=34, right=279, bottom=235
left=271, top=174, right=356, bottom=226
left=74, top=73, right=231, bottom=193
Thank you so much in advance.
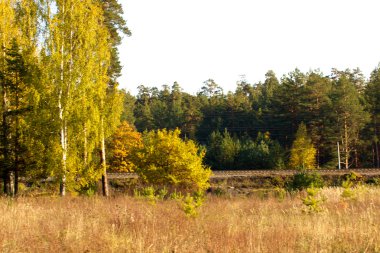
left=289, top=123, right=316, bottom=170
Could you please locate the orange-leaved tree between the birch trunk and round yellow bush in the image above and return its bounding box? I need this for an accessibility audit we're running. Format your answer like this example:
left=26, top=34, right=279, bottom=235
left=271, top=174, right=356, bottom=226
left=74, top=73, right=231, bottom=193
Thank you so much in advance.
left=111, top=121, right=142, bottom=172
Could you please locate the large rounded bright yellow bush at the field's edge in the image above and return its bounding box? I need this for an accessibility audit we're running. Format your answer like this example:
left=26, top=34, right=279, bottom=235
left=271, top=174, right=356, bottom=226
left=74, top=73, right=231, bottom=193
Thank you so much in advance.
left=133, top=129, right=211, bottom=190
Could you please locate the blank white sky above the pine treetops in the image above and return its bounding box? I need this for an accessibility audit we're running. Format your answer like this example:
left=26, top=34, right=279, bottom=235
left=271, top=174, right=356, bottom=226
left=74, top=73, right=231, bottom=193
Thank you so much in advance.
left=119, top=0, right=380, bottom=94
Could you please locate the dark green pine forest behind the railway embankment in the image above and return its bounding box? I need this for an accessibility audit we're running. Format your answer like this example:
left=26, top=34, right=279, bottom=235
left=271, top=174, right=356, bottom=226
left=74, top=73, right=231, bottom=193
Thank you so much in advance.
left=122, top=68, right=380, bottom=169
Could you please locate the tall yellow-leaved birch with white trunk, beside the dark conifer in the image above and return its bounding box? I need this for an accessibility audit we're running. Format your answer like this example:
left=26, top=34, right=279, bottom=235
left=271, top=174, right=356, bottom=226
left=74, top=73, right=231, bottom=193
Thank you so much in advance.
left=37, top=0, right=113, bottom=196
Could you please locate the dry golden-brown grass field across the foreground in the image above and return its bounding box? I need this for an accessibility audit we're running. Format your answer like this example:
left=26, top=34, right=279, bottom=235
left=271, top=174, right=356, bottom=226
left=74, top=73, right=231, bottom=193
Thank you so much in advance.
left=0, top=188, right=380, bottom=252
